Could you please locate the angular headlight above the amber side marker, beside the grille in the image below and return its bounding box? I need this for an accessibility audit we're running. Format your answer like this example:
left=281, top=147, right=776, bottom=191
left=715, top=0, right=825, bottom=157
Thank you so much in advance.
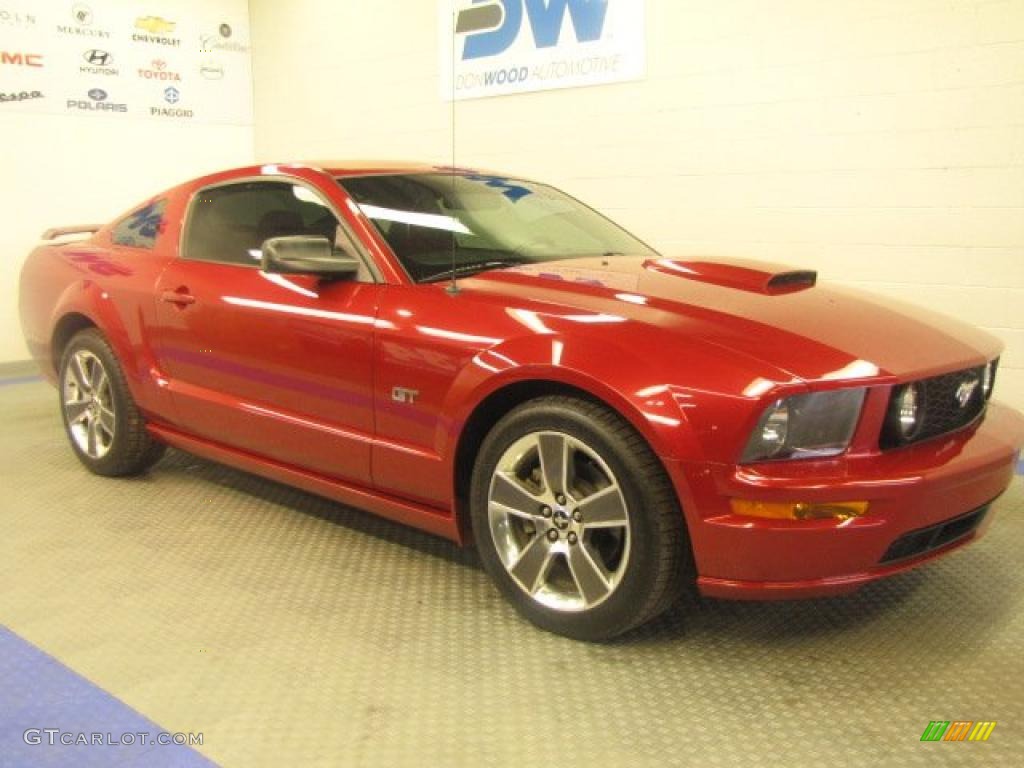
left=740, top=388, right=865, bottom=463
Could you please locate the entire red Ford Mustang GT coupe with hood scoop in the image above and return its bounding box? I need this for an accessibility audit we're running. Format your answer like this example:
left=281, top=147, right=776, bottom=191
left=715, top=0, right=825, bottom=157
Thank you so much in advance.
left=20, top=163, right=1024, bottom=639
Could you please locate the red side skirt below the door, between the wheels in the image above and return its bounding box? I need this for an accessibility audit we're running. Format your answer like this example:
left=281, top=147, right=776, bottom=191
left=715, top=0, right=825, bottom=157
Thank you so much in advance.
left=146, top=424, right=463, bottom=544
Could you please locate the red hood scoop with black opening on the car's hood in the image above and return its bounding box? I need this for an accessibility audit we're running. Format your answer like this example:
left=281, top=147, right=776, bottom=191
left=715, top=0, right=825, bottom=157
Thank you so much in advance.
left=643, top=259, right=818, bottom=296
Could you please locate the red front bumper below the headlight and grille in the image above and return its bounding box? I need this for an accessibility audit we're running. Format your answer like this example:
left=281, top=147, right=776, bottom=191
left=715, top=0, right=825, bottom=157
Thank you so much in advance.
left=670, top=403, right=1024, bottom=600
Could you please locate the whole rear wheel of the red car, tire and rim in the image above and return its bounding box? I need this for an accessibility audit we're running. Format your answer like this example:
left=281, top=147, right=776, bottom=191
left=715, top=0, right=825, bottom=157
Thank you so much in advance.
left=60, top=328, right=165, bottom=477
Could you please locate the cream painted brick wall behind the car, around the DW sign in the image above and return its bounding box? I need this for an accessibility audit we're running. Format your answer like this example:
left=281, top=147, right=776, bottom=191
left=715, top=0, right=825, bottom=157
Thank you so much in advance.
left=251, top=0, right=1024, bottom=409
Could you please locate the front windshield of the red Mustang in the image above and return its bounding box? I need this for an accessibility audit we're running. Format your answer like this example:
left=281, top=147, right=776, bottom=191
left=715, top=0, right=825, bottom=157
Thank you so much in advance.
left=338, top=173, right=657, bottom=283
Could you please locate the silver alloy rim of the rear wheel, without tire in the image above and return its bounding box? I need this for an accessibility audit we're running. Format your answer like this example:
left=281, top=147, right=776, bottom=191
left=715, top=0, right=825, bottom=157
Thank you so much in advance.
left=61, top=349, right=117, bottom=459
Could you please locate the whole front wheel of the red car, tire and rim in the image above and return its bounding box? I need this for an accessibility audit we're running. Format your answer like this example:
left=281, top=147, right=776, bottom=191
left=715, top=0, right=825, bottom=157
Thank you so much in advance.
left=471, top=396, right=689, bottom=640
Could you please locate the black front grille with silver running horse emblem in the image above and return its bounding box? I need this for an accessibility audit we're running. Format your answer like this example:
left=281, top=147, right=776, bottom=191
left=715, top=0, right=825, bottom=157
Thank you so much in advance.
left=880, top=366, right=985, bottom=451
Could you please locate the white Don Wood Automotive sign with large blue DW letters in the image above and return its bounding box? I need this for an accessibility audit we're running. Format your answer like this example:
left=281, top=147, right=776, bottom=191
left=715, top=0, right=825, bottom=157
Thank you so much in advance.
left=439, top=0, right=647, bottom=100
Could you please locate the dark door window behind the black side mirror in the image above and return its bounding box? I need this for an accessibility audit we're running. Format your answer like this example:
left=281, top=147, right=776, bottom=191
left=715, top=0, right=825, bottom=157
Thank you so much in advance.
left=182, top=181, right=338, bottom=266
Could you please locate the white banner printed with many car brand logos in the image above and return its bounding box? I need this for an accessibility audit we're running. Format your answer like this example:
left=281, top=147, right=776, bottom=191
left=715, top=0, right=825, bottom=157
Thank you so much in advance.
left=0, top=0, right=253, bottom=125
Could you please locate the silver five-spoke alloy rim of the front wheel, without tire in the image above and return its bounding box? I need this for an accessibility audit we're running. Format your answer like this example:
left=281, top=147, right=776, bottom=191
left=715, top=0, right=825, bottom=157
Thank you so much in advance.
left=487, top=431, right=630, bottom=611
